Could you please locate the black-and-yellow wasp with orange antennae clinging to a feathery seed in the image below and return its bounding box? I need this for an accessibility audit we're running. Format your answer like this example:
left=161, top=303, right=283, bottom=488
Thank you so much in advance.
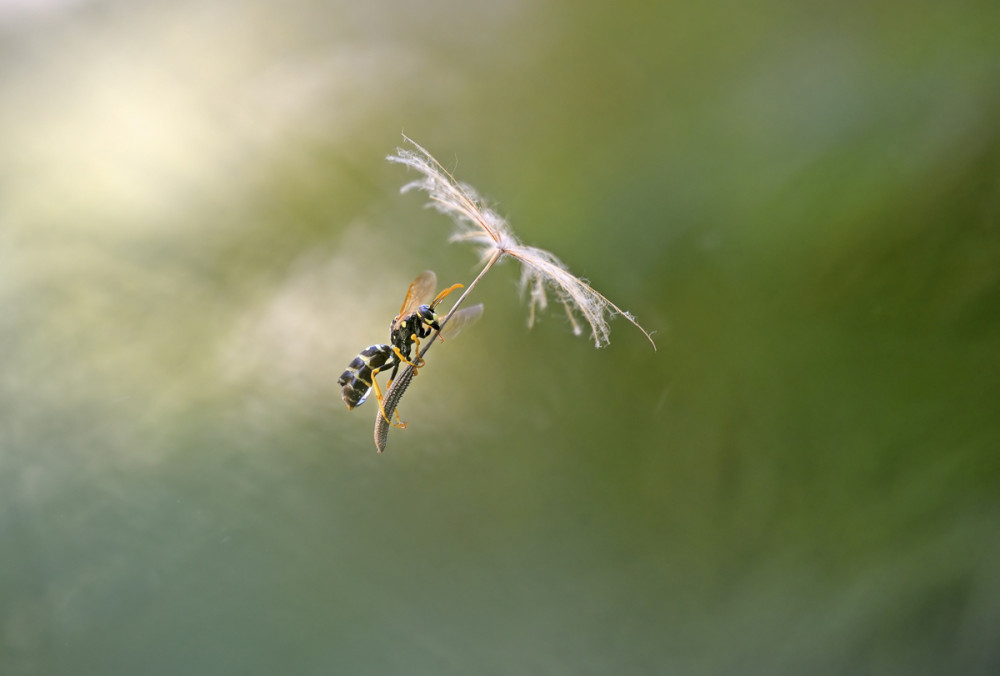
left=337, top=270, right=483, bottom=428
